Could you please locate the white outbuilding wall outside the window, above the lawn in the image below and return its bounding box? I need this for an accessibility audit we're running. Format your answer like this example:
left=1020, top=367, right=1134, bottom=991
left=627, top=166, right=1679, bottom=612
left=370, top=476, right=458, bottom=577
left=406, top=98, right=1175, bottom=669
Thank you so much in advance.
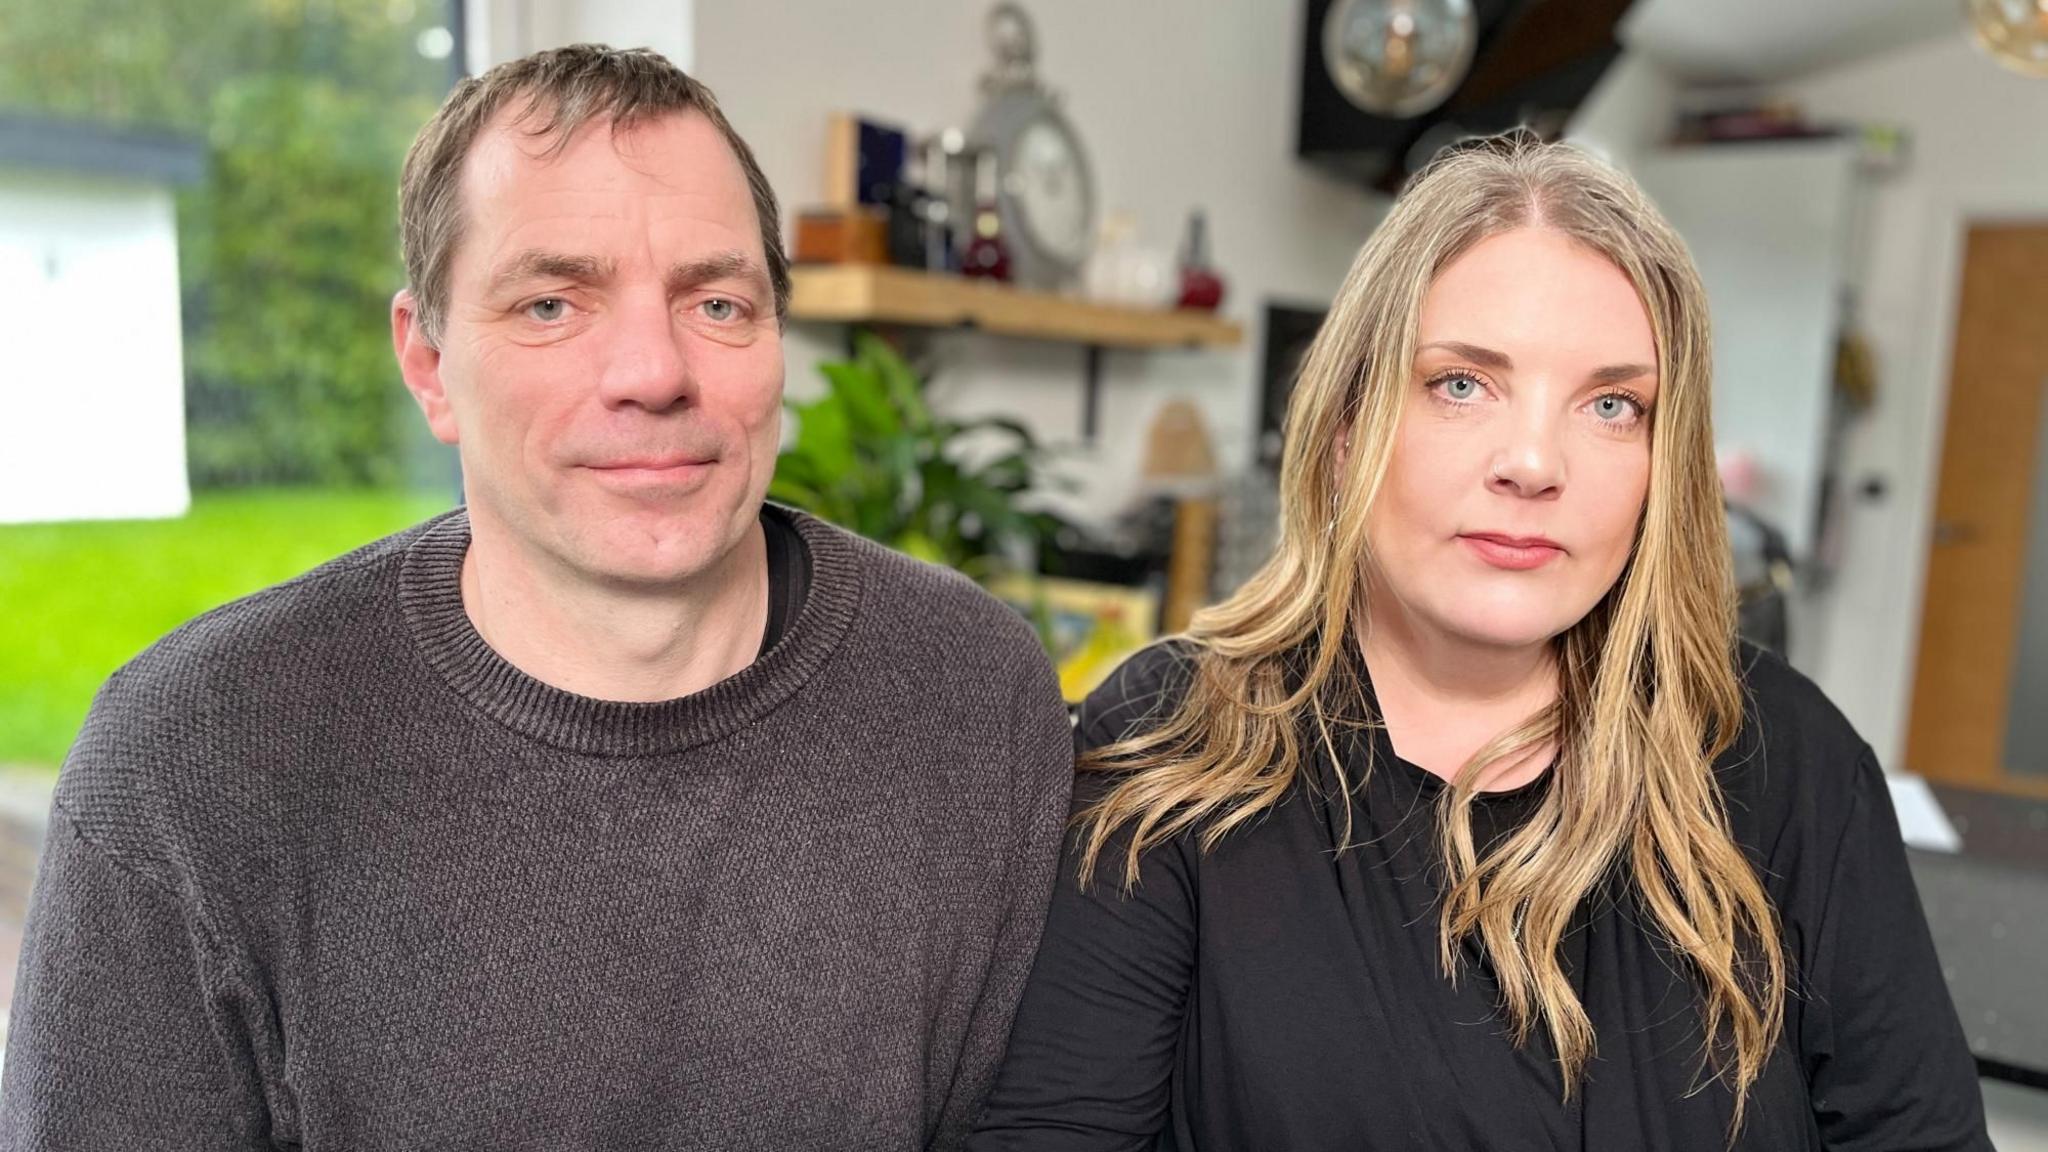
left=0, top=170, right=190, bottom=523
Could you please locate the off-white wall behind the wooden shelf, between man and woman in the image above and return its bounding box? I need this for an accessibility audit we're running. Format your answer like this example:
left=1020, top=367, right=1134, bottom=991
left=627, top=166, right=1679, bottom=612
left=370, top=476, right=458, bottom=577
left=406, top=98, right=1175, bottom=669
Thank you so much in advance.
left=694, top=0, right=1384, bottom=519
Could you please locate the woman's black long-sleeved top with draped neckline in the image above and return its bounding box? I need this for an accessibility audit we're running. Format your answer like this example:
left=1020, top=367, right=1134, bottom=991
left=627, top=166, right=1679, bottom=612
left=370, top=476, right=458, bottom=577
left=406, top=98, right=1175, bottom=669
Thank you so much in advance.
left=969, top=646, right=1989, bottom=1152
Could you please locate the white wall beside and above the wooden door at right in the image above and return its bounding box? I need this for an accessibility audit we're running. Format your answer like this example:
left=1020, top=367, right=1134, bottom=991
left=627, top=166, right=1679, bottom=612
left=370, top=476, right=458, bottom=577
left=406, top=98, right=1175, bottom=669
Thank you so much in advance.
left=1782, top=37, right=2048, bottom=767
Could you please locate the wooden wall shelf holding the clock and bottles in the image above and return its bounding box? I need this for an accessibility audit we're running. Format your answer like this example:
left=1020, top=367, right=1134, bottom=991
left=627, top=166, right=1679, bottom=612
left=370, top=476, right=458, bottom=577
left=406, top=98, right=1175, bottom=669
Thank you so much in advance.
left=788, top=264, right=1245, bottom=348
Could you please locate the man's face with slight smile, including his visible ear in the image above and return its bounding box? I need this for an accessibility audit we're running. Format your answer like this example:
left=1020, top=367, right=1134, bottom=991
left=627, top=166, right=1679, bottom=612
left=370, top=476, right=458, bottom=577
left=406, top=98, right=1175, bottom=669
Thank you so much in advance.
left=393, top=113, right=782, bottom=584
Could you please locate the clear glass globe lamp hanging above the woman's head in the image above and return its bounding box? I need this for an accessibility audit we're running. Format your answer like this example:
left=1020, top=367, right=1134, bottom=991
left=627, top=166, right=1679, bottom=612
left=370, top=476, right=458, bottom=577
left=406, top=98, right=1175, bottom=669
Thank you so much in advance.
left=1323, top=0, right=1479, bottom=117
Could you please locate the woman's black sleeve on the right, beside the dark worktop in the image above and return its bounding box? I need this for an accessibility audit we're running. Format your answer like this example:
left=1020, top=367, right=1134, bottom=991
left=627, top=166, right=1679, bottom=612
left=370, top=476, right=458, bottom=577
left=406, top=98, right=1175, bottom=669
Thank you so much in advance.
left=1800, top=748, right=1991, bottom=1152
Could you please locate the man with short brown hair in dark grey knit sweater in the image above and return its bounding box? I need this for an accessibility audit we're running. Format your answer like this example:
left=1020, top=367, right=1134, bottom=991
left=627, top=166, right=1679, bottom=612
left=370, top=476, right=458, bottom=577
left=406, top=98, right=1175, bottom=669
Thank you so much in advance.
left=0, top=45, right=1071, bottom=1152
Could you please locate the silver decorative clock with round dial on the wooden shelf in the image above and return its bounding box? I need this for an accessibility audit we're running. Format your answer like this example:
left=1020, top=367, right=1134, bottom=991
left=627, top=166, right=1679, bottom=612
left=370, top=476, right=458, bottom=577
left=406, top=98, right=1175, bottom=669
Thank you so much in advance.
left=969, top=0, right=1096, bottom=289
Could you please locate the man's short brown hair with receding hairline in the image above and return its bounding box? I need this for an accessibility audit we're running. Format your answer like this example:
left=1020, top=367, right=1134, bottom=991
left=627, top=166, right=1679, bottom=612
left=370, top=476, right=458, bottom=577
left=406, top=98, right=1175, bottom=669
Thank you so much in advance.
left=397, top=43, right=788, bottom=344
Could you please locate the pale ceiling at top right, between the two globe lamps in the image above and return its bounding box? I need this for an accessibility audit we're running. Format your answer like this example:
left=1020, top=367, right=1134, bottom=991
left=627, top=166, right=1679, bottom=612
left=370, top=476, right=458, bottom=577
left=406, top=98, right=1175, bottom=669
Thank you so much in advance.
left=1613, top=0, right=1964, bottom=84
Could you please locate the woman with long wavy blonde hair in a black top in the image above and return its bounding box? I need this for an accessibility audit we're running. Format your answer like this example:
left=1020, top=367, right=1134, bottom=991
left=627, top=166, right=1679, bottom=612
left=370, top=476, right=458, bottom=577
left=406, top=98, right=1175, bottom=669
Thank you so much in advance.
left=971, top=137, right=1989, bottom=1152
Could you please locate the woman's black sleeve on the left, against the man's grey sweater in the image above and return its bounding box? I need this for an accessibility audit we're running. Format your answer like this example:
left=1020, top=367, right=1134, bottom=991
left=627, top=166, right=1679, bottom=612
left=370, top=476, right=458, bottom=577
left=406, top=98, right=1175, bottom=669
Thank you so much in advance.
left=967, top=656, right=1196, bottom=1152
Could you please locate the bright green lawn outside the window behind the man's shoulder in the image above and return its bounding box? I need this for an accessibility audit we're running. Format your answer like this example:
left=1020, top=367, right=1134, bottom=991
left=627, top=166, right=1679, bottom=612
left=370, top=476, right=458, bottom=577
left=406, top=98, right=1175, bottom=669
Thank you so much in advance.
left=0, top=490, right=449, bottom=769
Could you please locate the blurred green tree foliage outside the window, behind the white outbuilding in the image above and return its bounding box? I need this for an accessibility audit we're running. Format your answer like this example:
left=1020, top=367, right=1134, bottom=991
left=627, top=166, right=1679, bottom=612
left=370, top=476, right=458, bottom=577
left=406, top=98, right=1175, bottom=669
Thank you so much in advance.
left=0, top=0, right=451, bottom=486
